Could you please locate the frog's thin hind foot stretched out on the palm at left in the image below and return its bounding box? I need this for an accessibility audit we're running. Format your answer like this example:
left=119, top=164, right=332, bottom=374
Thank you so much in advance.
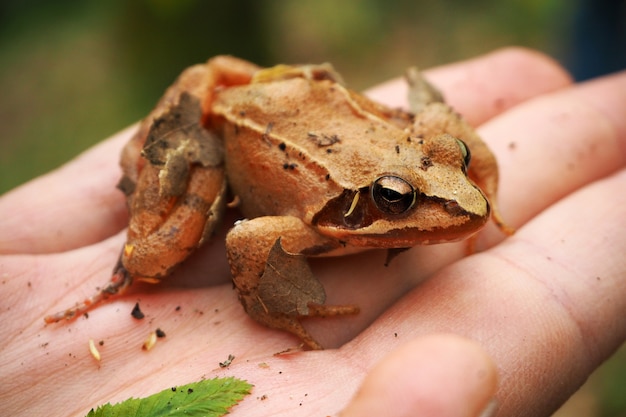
left=44, top=257, right=133, bottom=324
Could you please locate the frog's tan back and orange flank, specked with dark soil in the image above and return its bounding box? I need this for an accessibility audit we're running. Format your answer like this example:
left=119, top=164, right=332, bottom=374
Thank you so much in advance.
left=213, top=78, right=405, bottom=221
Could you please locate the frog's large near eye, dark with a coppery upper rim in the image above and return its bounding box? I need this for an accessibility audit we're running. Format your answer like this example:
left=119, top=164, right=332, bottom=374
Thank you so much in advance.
left=372, top=175, right=417, bottom=214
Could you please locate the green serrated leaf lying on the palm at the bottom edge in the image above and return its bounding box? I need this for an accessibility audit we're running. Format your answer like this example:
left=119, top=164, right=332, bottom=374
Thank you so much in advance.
left=87, top=378, right=252, bottom=417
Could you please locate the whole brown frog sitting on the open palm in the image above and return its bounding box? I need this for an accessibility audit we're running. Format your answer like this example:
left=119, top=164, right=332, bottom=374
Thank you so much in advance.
left=45, top=56, right=511, bottom=349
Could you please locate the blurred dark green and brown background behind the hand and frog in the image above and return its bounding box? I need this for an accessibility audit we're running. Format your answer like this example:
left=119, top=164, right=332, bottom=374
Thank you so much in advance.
left=0, top=0, right=626, bottom=417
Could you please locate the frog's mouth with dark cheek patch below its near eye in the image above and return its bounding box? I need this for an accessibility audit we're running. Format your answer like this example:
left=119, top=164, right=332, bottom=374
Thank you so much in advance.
left=311, top=187, right=490, bottom=248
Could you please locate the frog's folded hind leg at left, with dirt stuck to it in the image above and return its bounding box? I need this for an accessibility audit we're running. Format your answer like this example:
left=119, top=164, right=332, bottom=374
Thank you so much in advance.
left=45, top=56, right=259, bottom=323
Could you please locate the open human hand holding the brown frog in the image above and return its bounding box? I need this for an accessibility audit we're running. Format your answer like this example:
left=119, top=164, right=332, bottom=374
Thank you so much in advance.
left=0, top=50, right=626, bottom=417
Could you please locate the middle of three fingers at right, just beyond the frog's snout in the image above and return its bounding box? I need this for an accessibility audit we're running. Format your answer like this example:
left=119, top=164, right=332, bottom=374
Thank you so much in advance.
left=479, top=72, right=626, bottom=244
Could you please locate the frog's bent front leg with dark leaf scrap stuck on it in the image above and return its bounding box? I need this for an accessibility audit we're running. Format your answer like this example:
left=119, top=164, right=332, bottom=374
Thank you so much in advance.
left=226, top=216, right=359, bottom=349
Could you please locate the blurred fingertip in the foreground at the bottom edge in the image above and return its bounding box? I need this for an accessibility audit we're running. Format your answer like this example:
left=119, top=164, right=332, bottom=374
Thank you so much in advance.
left=341, top=335, right=497, bottom=417
